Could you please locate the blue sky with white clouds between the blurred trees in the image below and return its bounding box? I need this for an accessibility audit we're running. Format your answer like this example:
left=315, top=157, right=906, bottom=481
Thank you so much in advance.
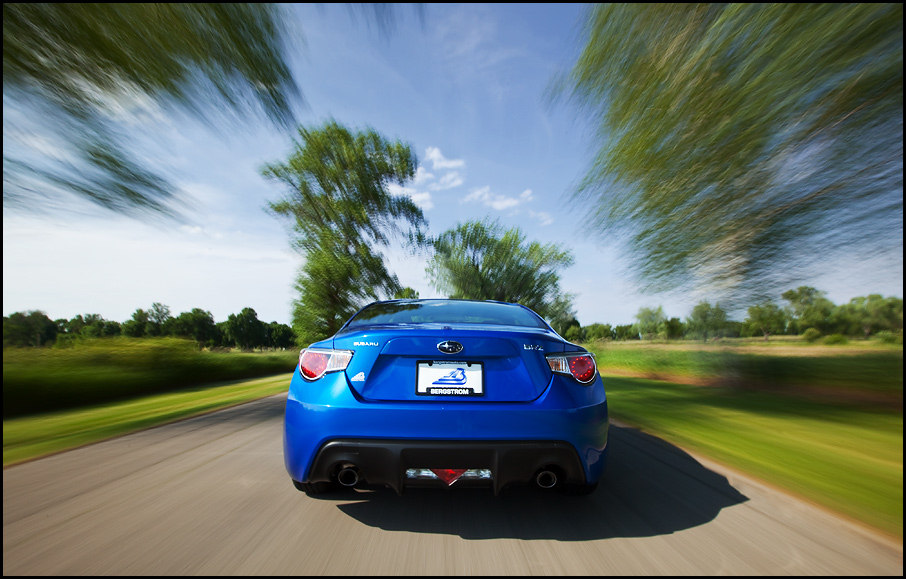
left=3, top=4, right=903, bottom=325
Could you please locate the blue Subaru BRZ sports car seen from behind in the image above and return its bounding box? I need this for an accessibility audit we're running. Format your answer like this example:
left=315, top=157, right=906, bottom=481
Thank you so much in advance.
left=283, top=299, right=609, bottom=495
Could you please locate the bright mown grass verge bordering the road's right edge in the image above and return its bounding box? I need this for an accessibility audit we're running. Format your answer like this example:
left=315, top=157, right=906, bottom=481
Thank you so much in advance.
left=605, top=377, right=903, bottom=539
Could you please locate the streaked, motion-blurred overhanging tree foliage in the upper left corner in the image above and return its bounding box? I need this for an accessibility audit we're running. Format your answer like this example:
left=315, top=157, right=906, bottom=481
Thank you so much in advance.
left=3, top=3, right=423, bottom=216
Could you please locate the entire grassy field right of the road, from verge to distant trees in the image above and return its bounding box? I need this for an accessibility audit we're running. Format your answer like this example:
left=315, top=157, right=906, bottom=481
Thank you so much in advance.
left=587, top=340, right=903, bottom=539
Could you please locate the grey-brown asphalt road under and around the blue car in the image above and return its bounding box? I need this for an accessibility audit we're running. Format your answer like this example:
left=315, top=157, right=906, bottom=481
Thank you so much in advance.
left=3, top=394, right=903, bottom=576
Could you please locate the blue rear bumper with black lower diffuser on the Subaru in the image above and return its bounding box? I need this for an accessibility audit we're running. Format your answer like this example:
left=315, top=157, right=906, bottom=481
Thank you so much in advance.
left=283, top=372, right=609, bottom=493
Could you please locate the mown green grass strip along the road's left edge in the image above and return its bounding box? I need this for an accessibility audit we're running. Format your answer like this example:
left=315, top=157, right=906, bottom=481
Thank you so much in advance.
left=3, top=373, right=291, bottom=467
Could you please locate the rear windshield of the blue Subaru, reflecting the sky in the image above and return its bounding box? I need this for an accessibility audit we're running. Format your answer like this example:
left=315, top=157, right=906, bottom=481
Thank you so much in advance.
left=345, top=300, right=547, bottom=329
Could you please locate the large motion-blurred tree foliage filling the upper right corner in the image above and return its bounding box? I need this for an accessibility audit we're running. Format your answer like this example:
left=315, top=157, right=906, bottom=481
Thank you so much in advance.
left=557, top=3, right=903, bottom=304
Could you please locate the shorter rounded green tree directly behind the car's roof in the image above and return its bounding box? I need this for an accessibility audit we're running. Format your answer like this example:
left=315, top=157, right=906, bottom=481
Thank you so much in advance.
left=427, top=221, right=578, bottom=324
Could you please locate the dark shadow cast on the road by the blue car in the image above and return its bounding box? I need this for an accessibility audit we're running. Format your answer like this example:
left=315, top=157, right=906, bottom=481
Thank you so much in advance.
left=316, top=425, right=748, bottom=541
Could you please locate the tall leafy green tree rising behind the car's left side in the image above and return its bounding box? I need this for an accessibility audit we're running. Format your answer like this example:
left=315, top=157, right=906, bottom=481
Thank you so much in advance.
left=262, top=120, right=427, bottom=344
